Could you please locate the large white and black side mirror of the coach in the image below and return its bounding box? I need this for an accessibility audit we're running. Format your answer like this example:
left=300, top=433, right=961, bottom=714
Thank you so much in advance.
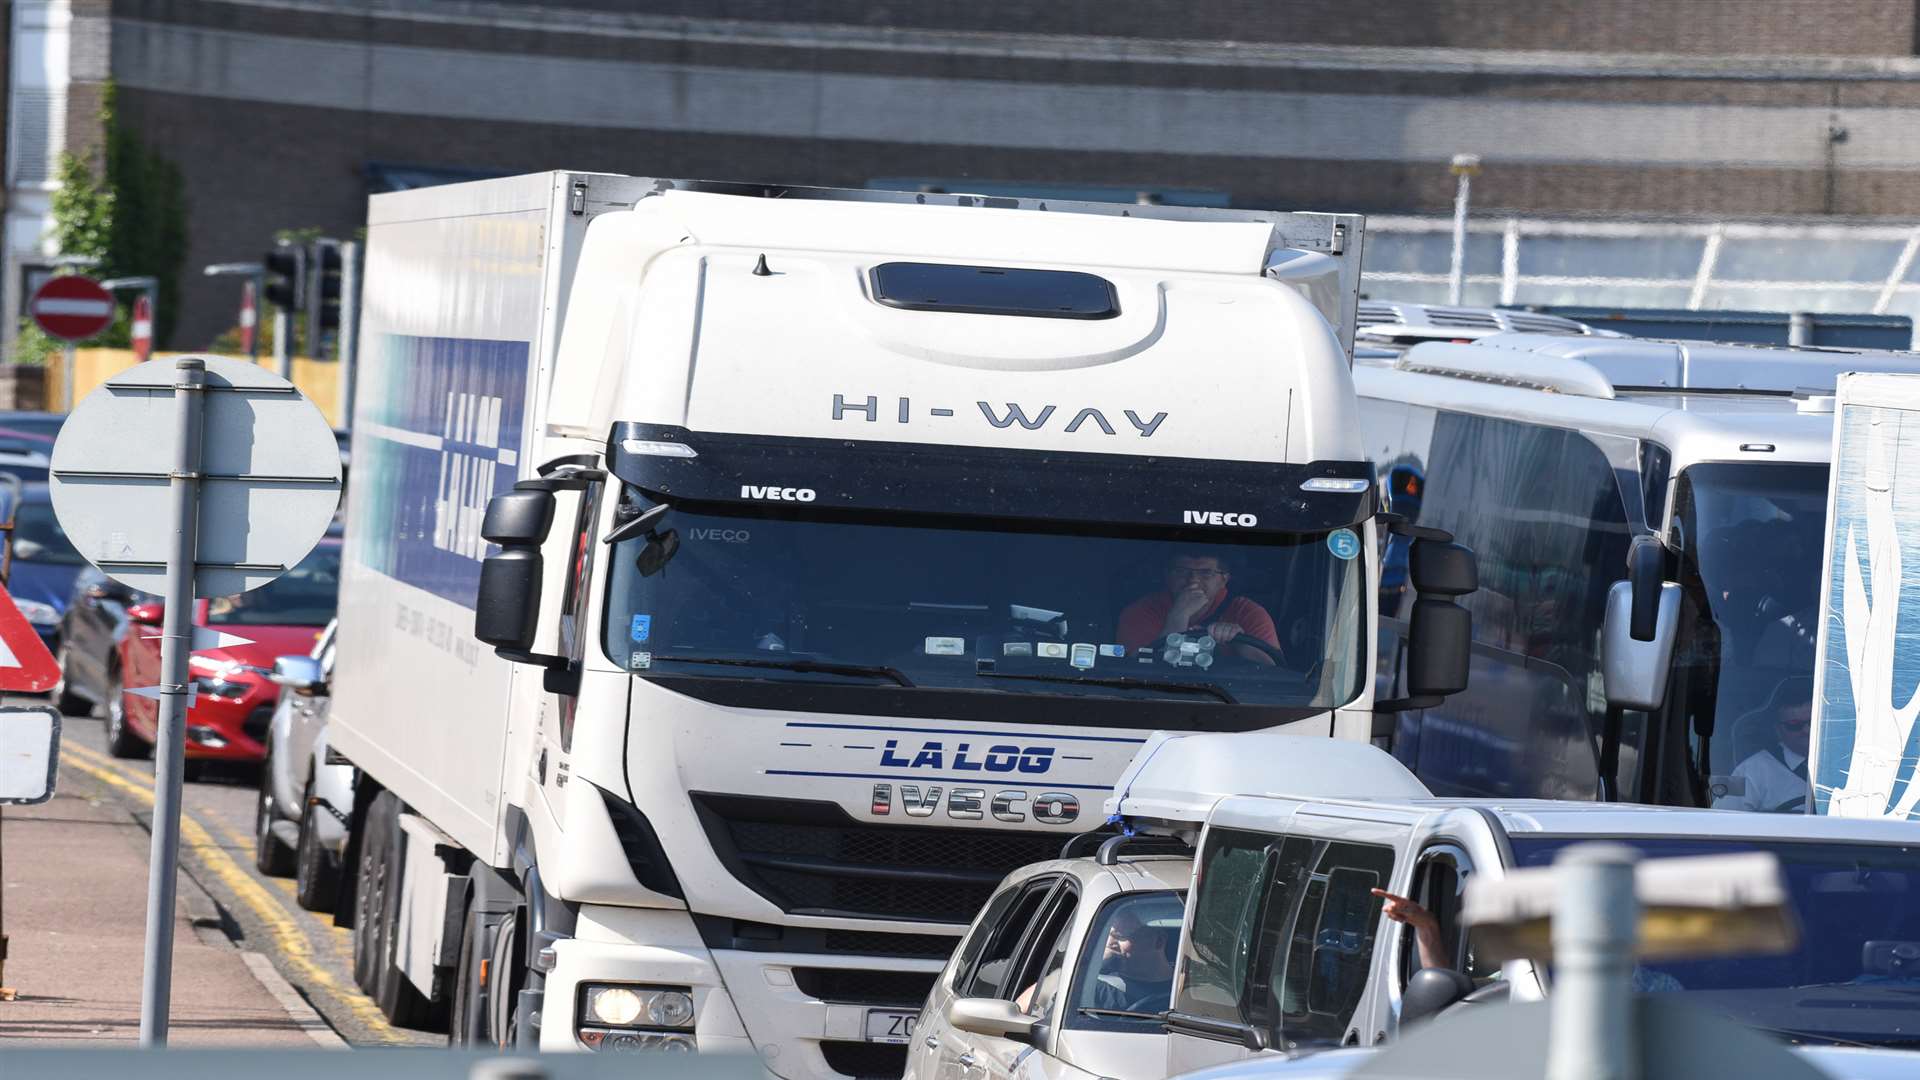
left=1599, top=536, right=1680, bottom=711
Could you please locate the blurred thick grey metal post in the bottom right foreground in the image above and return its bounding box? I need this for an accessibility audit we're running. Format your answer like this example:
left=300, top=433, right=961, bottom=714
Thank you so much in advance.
left=1548, top=844, right=1640, bottom=1080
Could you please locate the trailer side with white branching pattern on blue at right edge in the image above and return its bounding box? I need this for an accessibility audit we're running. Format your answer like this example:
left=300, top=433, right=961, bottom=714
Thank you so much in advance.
left=1809, top=373, right=1920, bottom=821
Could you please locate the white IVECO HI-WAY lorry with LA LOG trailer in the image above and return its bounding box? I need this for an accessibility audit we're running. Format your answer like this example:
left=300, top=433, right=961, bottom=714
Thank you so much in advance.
left=330, top=173, right=1473, bottom=1060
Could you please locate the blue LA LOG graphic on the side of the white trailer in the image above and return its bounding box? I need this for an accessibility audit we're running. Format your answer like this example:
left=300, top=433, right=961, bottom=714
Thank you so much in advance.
left=351, top=334, right=528, bottom=609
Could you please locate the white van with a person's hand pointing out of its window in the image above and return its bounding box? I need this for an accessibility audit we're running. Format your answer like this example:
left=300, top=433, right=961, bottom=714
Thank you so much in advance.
left=1110, top=736, right=1920, bottom=1076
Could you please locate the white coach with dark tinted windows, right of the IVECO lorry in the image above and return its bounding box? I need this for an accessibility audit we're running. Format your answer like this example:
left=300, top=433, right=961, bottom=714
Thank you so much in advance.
left=1354, top=332, right=1920, bottom=809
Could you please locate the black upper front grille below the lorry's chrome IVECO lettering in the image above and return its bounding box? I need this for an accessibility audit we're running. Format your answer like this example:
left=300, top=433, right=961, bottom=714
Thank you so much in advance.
left=693, top=796, right=1060, bottom=922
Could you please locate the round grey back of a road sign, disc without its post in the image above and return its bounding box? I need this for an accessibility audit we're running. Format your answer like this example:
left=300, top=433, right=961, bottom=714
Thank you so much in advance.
left=48, top=356, right=340, bottom=598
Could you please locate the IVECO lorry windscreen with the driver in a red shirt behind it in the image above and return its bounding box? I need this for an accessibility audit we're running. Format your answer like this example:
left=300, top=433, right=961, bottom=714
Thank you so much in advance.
left=605, top=507, right=1367, bottom=709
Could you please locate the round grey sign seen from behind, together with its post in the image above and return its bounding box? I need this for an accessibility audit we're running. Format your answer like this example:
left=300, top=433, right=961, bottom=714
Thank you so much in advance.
left=50, top=357, right=340, bottom=1045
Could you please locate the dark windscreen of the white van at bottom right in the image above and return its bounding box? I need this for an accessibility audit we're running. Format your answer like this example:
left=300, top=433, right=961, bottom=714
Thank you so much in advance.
left=1513, top=836, right=1920, bottom=1045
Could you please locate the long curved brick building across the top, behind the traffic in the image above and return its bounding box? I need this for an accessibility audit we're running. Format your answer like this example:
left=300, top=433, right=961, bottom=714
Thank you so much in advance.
left=15, top=0, right=1920, bottom=346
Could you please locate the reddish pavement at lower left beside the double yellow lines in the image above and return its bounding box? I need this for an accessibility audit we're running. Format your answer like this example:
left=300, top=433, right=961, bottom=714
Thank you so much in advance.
left=0, top=722, right=346, bottom=1049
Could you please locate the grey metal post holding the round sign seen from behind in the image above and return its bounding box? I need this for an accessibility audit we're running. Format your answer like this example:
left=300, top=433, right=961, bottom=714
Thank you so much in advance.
left=140, top=357, right=207, bottom=1047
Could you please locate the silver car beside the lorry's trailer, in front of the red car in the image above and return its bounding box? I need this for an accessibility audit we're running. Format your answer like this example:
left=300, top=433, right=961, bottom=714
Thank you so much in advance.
left=253, top=621, right=353, bottom=911
